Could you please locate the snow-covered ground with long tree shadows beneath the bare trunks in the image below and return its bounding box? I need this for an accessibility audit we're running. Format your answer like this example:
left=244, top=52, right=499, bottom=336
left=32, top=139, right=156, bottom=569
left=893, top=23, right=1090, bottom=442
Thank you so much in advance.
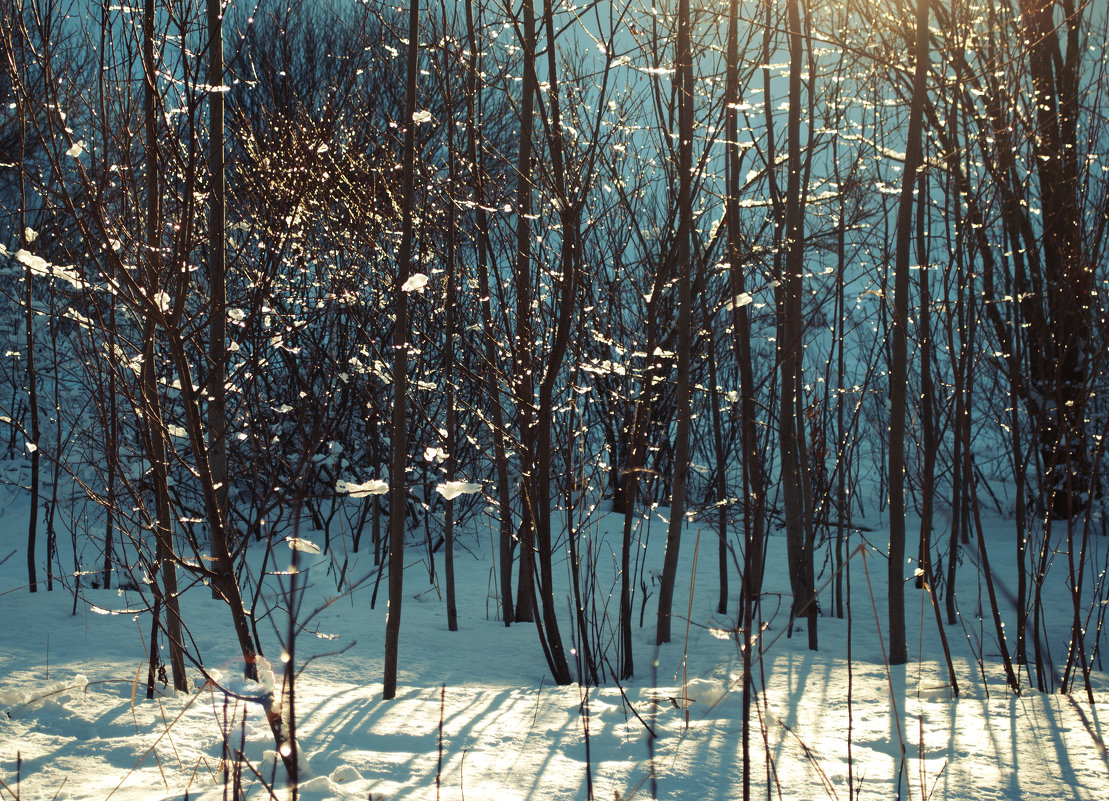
left=0, top=492, right=1109, bottom=801
